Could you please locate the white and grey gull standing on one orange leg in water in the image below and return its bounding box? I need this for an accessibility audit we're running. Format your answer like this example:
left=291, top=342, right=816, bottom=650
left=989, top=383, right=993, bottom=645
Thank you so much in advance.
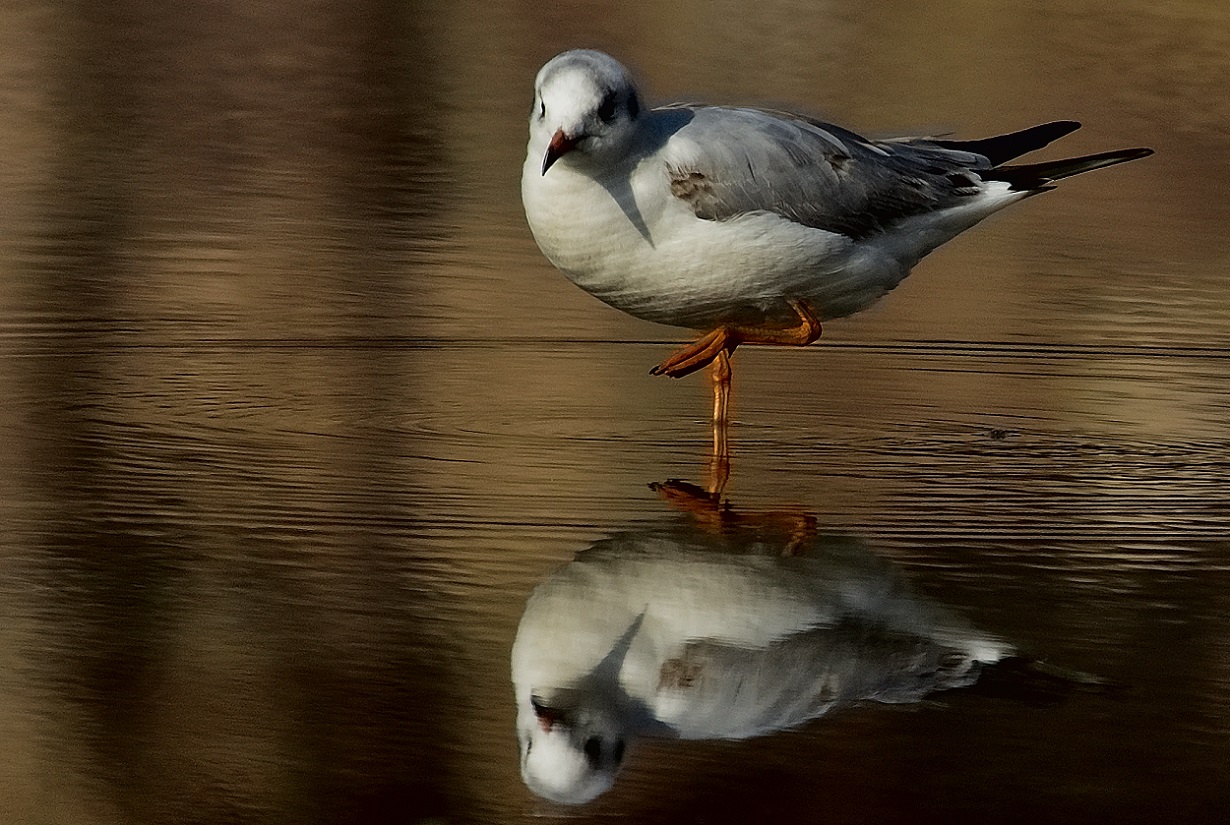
left=522, top=49, right=1153, bottom=437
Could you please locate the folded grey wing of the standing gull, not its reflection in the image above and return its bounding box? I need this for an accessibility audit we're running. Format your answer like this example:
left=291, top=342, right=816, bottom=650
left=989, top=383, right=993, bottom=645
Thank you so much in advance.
left=668, top=106, right=991, bottom=239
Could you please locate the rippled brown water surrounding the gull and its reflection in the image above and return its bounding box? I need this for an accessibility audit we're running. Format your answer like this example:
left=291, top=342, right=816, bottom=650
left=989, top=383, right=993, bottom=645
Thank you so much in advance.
left=0, top=0, right=1230, bottom=825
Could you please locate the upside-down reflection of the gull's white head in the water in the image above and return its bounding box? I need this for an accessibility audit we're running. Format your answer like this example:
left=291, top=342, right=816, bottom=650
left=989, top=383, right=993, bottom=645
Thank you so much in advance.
left=518, top=697, right=625, bottom=805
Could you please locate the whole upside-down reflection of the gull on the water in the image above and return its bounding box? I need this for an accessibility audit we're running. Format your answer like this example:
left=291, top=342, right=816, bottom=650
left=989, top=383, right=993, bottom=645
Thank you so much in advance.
left=512, top=482, right=1082, bottom=803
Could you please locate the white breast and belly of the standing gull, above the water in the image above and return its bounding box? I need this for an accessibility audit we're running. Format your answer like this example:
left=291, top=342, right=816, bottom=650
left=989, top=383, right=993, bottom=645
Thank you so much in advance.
left=522, top=157, right=914, bottom=328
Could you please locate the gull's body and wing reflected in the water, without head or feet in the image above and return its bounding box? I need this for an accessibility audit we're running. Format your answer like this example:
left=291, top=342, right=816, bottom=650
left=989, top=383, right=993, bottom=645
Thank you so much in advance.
left=513, top=530, right=1009, bottom=738
